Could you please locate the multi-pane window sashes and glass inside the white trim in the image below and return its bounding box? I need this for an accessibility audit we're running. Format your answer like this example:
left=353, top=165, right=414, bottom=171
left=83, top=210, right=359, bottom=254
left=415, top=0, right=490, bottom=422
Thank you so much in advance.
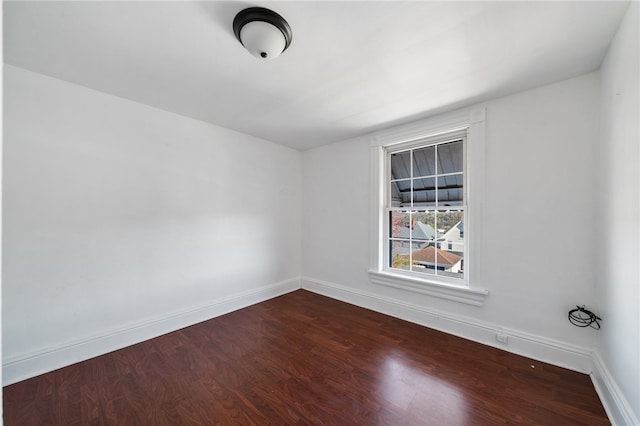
left=384, top=130, right=466, bottom=279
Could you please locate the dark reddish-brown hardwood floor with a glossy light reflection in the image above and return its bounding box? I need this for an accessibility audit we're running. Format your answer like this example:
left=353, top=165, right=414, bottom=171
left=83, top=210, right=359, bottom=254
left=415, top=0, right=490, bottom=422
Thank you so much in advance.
left=4, top=290, right=609, bottom=426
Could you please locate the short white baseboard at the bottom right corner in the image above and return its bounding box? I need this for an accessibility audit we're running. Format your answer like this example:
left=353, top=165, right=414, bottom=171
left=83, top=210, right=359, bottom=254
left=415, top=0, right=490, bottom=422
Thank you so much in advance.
left=591, top=352, right=640, bottom=426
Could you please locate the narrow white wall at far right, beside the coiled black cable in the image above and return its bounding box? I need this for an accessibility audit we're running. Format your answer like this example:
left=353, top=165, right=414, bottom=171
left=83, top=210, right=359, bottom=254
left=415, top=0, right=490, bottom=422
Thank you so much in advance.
left=597, top=2, right=640, bottom=424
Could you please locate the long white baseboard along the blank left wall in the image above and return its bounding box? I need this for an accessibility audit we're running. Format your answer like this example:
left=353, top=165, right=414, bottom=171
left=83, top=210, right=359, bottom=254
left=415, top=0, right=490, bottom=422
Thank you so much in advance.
left=2, top=278, right=300, bottom=386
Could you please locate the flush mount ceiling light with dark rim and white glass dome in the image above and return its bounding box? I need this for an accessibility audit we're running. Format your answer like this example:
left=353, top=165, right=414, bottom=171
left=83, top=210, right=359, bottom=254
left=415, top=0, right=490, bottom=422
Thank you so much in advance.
left=233, top=7, right=291, bottom=59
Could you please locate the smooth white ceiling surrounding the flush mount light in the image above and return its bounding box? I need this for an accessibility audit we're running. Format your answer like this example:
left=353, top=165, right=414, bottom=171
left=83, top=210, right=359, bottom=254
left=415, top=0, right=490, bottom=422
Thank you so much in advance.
left=4, top=1, right=628, bottom=150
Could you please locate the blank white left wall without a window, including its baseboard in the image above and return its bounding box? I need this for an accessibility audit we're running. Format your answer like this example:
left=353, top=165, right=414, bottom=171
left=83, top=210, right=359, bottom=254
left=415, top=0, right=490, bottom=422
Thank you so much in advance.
left=2, top=65, right=302, bottom=383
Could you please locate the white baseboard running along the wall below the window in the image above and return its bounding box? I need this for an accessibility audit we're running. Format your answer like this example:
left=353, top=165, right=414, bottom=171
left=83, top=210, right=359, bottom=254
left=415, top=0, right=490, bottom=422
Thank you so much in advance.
left=302, top=277, right=592, bottom=374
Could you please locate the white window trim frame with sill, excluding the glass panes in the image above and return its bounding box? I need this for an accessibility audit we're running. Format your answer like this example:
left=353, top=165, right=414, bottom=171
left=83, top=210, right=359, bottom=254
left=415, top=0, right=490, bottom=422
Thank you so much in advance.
left=369, top=108, right=489, bottom=306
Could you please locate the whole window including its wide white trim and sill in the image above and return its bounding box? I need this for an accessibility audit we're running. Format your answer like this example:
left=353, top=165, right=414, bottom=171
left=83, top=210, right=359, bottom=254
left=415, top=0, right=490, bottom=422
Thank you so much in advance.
left=369, top=109, right=488, bottom=306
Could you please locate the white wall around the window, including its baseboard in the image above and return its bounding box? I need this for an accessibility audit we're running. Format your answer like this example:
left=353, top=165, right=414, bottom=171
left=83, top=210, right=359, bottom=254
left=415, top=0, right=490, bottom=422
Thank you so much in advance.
left=302, top=73, right=599, bottom=372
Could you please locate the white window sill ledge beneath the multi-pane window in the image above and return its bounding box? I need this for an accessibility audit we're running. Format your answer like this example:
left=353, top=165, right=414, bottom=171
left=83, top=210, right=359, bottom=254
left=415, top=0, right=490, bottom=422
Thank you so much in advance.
left=369, top=271, right=489, bottom=306
